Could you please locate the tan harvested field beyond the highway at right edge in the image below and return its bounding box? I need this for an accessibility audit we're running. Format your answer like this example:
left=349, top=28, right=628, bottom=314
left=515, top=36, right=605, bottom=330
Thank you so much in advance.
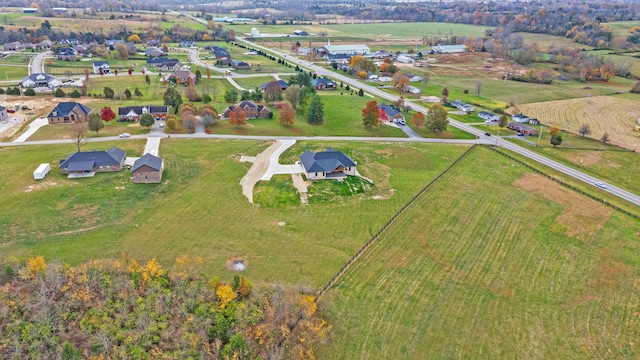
left=518, top=96, right=640, bottom=150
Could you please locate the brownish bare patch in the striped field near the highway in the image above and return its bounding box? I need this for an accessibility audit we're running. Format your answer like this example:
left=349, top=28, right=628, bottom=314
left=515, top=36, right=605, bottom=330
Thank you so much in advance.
left=514, top=173, right=612, bottom=241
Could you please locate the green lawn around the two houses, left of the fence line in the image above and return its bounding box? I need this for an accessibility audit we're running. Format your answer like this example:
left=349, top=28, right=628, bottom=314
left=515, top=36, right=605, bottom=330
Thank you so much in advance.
left=0, top=138, right=467, bottom=288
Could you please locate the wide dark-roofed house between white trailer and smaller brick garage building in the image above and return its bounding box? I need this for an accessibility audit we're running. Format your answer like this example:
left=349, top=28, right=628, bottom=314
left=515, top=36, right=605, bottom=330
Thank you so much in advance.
left=58, top=146, right=127, bottom=178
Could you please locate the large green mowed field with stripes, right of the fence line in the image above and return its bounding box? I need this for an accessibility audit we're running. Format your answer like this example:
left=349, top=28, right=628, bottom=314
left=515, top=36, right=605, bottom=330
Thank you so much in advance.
left=318, top=148, right=640, bottom=359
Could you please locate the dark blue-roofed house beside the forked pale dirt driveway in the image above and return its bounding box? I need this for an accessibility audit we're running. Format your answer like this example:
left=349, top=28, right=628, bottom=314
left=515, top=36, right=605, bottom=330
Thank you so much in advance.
left=300, top=148, right=356, bottom=180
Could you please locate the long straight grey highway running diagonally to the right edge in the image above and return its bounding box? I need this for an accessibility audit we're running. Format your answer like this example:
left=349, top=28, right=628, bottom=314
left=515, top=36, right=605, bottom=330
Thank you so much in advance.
left=237, top=38, right=640, bottom=206
